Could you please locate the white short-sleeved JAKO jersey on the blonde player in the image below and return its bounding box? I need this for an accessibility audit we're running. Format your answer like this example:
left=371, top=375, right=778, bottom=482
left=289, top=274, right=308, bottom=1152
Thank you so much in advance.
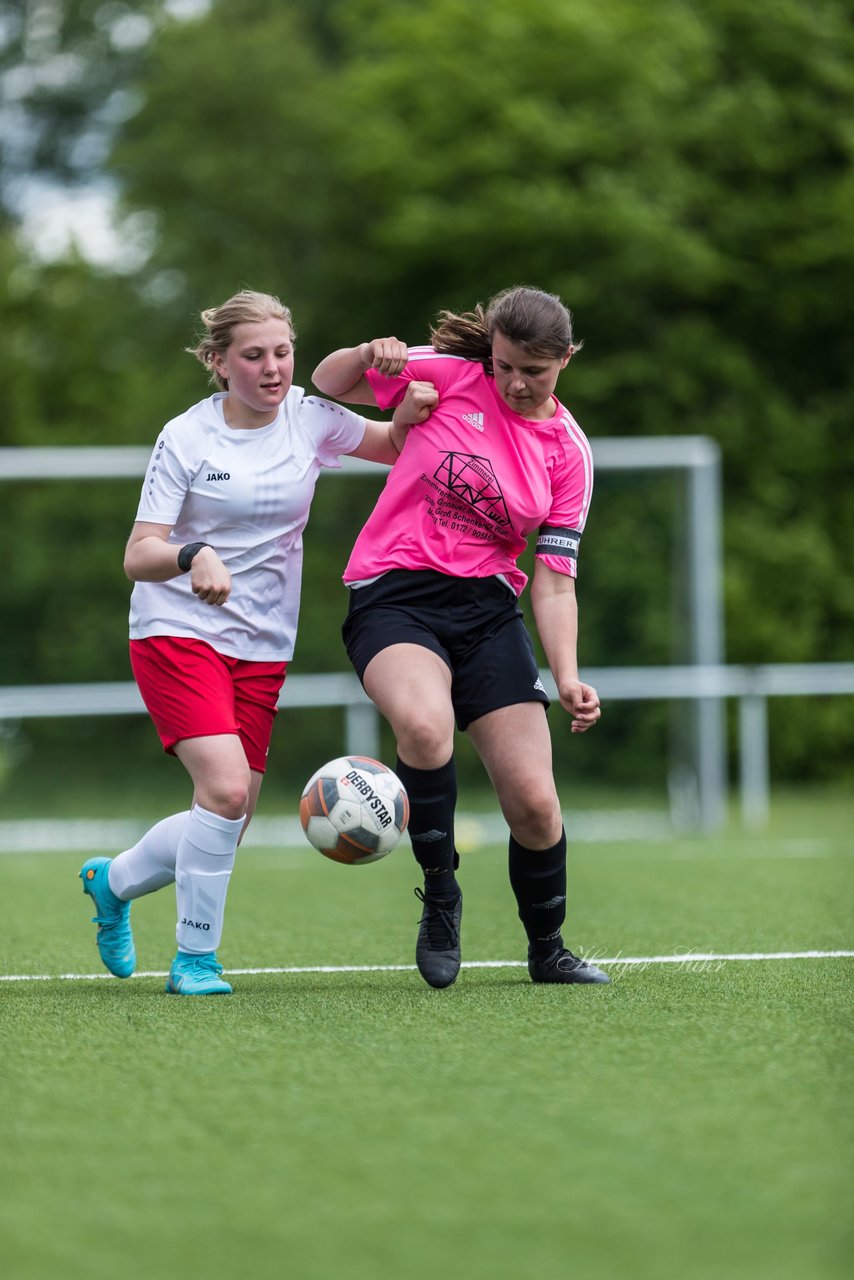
left=131, top=387, right=365, bottom=662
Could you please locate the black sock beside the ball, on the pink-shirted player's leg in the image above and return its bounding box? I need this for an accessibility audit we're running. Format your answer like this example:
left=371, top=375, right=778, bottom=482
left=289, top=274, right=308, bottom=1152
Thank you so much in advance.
left=394, top=755, right=460, bottom=897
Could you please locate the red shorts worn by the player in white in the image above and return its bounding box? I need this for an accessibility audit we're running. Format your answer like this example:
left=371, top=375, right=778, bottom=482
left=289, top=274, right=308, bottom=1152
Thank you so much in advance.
left=131, top=636, right=288, bottom=773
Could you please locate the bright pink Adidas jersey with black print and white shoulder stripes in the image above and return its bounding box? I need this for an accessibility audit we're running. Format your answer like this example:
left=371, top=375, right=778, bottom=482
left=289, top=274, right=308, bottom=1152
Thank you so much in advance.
left=344, top=347, right=593, bottom=595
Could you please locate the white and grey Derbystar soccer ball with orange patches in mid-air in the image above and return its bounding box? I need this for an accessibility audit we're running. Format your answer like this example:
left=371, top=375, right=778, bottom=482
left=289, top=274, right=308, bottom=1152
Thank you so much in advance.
left=300, top=755, right=410, bottom=867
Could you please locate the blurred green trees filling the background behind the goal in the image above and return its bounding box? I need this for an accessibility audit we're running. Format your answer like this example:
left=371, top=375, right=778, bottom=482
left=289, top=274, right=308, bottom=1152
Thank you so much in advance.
left=0, top=0, right=854, bottom=777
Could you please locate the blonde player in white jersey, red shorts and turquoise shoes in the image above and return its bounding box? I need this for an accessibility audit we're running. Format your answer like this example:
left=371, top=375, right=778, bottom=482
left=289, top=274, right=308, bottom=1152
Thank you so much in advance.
left=79, top=291, right=414, bottom=996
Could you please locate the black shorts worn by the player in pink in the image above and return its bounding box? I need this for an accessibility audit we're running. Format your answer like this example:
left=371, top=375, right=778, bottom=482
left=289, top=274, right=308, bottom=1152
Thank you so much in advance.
left=342, top=568, right=549, bottom=730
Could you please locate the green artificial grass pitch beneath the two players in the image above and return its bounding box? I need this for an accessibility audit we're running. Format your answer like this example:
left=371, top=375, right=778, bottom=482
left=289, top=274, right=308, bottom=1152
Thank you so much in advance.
left=0, top=809, right=854, bottom=1280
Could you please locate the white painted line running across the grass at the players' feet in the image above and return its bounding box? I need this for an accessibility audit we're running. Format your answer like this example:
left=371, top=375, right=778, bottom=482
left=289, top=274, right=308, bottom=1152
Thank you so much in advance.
left=0, top=951, right=854, bottom=982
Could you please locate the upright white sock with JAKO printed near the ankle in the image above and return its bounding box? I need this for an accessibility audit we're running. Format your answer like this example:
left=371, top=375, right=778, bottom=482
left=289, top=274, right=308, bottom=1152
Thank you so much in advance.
left=175, top=805, right=246, bottom=955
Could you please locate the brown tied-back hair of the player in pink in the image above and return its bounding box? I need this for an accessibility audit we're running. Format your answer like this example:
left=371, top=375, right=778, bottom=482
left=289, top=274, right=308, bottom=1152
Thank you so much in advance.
left=430, top=284, right=583, bottom=369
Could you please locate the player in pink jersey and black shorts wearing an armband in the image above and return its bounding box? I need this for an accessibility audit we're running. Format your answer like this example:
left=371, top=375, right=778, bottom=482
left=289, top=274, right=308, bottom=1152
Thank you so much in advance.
left=314, top=287, right=608, bottom=987
